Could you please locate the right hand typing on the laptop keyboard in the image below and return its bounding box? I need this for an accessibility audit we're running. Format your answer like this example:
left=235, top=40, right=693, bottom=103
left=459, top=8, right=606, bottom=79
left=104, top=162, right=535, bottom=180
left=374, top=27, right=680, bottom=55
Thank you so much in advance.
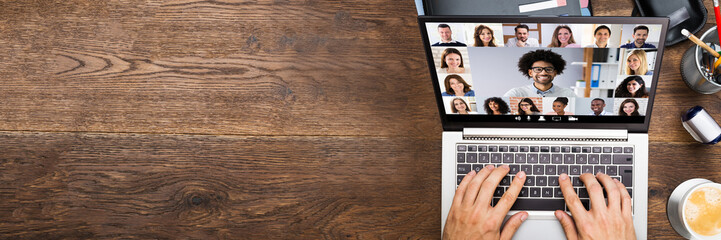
left=556, top=173, right=636, bottom=240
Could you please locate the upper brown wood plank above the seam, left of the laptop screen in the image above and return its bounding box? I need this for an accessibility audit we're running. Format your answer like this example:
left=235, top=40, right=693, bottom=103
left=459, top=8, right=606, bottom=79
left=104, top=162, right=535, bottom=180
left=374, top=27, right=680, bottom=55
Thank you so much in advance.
left=0, top=0, right=440, bottom=137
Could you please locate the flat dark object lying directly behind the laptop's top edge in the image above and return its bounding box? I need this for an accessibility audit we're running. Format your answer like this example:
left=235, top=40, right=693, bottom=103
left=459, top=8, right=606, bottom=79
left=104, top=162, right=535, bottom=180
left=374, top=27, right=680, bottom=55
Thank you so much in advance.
left=416, top=0, right=591, bottom=16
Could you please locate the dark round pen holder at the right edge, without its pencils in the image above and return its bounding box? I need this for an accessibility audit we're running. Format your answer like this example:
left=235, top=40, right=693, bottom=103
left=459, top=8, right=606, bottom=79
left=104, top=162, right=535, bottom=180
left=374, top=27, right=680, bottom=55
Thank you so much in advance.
left=681, top=27, right=721, bottom=94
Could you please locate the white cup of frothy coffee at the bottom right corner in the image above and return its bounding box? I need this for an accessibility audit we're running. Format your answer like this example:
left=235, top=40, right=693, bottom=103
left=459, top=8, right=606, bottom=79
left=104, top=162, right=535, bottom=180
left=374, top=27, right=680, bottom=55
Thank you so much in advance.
left=666, top=178, right=721, bottom=240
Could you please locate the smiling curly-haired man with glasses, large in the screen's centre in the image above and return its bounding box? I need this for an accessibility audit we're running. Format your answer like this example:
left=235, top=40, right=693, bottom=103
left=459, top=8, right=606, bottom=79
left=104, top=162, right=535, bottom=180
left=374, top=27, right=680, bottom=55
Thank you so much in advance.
left=503, top=49, right=576, bottom=98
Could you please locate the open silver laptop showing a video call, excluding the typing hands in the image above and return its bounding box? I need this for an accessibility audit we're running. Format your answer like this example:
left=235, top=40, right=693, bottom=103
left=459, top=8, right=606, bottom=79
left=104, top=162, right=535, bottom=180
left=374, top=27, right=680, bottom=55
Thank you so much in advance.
left=418, top=16, right=669, bottom=239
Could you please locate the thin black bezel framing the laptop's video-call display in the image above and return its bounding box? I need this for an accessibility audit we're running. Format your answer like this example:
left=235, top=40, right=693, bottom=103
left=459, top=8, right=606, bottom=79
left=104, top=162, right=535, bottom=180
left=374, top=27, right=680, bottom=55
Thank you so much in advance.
left=418, top=16, right=669, bottom=133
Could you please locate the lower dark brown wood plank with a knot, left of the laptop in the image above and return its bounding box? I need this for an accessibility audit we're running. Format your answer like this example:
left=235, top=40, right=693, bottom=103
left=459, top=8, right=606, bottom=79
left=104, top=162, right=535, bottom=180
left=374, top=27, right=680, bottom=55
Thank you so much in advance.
left=0, top=132, right=440, bottom=239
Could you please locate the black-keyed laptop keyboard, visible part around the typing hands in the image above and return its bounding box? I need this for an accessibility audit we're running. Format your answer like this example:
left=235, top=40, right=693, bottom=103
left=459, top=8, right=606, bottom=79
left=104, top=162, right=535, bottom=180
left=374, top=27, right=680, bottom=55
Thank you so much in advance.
left=456, top=144, right=634, bottom=211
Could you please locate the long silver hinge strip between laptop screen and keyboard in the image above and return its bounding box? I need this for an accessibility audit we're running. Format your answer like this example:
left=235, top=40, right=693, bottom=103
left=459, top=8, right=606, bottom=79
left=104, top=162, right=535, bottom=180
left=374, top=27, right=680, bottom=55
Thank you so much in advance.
left=463, top=128, right=628, bottom=142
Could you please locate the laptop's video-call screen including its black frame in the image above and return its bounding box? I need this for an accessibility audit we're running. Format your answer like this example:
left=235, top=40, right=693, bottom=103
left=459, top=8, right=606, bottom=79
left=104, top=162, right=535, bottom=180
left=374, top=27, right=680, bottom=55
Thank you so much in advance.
left=419, top=17, right=668, bottom=132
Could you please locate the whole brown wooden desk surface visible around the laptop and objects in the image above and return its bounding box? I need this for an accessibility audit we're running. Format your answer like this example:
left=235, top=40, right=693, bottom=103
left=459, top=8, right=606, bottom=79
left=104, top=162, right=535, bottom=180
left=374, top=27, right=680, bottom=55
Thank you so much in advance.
left=0, top=0, right=721, bottom=239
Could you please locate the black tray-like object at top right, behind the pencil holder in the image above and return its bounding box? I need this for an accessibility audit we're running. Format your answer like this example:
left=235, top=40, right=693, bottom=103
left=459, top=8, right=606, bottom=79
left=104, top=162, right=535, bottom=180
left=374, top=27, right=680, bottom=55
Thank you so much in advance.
left=631, top=0, right=707, bottom=46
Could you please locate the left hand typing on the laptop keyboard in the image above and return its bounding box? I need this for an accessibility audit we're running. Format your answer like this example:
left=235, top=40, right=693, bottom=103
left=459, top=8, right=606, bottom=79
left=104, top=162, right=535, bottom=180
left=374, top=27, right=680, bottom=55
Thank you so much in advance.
left=443, top=165, right=528, bottom=239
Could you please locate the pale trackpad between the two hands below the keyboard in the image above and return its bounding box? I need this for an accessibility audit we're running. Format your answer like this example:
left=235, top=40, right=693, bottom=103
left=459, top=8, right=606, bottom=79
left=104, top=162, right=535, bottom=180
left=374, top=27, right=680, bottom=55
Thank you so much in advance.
left=504, top=218, right=566, bottom=240
